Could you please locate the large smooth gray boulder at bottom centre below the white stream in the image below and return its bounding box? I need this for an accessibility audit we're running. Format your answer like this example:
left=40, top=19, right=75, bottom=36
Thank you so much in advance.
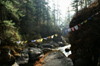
left=43, top=51, right=73, bottom=66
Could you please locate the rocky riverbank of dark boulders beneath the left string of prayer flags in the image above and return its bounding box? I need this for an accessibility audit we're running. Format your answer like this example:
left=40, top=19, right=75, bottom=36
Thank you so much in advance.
left=0, top=35, right=67, bottom=66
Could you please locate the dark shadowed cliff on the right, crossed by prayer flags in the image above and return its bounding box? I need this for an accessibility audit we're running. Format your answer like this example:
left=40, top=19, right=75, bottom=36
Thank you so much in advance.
left=69, top=0, right=100, bottom=66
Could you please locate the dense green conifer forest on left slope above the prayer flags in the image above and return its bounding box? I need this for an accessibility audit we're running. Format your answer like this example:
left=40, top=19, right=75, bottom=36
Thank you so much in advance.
left=0, top=0, right=60, bottom=40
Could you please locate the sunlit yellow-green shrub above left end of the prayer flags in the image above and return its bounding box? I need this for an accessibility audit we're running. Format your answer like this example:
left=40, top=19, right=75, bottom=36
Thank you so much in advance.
left=3, top=20, right=21, bottom=40
